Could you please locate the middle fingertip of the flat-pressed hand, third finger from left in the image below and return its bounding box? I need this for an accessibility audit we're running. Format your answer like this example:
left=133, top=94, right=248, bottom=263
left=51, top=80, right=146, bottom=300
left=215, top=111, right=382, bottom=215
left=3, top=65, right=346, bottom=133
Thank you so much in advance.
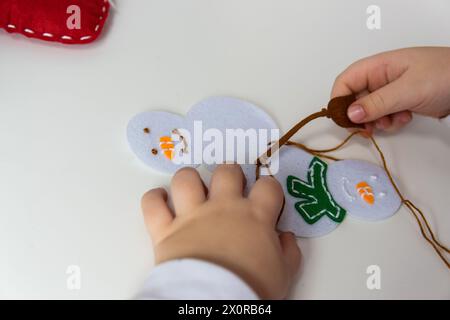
left=209, top=164, right=245, bottom=199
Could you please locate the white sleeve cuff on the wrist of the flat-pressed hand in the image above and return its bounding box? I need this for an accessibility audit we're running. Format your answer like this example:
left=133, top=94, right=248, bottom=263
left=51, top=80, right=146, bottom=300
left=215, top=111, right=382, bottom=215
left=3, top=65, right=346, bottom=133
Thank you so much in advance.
left=137, top=259, right=258, bottom=300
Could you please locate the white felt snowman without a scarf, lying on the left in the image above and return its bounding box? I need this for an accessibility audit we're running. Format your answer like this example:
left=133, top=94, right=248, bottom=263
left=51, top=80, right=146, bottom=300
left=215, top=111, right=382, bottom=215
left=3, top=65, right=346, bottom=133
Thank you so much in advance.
left=127, top=97, right=279, bottom=173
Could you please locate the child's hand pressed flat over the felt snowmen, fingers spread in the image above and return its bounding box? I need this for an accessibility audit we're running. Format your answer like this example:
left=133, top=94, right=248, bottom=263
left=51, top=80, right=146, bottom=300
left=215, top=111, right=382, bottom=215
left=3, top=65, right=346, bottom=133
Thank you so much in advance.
left=142, top=165, right=300, bottom=298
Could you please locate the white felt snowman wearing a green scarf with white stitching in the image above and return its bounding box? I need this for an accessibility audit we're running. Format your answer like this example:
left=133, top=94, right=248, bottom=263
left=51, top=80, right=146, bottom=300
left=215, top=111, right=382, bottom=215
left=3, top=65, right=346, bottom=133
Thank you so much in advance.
left=275, top=146, right=401, bottom=237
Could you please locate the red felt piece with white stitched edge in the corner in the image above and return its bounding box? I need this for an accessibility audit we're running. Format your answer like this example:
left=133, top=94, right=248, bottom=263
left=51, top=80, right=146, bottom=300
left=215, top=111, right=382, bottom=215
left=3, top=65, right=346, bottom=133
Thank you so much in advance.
left=0, top=0, right=110, bottom=44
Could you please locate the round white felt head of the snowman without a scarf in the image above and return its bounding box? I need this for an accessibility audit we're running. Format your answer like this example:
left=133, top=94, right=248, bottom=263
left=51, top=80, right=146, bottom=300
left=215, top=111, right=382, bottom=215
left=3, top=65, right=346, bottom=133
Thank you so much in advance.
left=127, top=111, right=197, bottom=173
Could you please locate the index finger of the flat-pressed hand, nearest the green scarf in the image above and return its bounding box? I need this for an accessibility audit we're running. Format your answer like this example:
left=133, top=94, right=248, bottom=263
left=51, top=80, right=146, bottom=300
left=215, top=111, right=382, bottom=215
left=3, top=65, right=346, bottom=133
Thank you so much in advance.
left=248, top=176, right=283, bottom=226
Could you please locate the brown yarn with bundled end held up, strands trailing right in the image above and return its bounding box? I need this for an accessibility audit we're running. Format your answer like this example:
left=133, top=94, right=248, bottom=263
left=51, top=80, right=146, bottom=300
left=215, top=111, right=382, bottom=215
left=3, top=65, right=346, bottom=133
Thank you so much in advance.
left=256, top=96, right=450, bottom=269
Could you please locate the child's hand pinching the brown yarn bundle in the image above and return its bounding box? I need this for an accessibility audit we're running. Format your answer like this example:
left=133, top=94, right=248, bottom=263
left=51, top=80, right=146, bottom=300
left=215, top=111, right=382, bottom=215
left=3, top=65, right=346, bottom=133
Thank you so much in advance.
left=331, top=47, right=450, bottom=131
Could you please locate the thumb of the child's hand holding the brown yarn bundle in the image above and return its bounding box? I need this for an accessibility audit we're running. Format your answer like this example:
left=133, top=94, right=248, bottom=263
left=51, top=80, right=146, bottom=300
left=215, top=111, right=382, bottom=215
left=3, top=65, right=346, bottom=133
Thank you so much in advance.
left=347, top=78, right=408, bottom=123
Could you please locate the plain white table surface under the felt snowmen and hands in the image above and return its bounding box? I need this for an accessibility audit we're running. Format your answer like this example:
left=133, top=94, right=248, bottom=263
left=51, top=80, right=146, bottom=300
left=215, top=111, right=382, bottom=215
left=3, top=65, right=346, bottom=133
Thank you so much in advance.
left=0, top=0, right=450, bottom=299
